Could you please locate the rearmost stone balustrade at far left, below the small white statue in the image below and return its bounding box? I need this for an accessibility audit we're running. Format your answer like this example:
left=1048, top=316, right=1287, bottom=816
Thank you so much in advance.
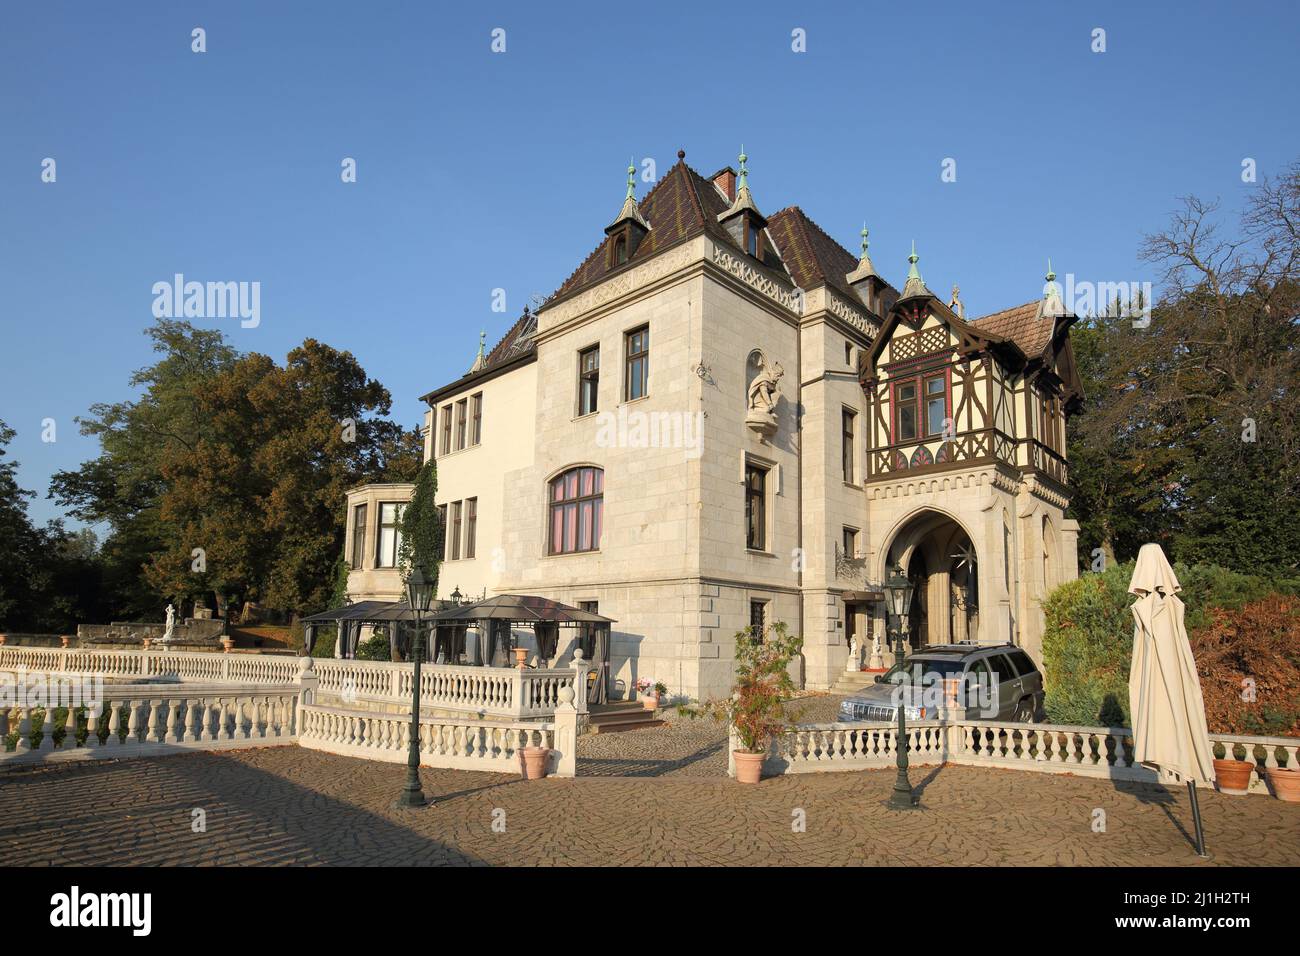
left=0, top=645, right=302, bottom=684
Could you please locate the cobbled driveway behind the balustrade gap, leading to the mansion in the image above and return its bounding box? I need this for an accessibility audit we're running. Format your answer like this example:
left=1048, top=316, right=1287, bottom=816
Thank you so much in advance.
left=577, top=693, right=844, bottom=778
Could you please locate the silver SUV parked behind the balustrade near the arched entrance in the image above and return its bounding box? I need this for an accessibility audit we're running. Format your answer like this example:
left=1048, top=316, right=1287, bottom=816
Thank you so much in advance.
left=840, top=644, right=1043, bottom=723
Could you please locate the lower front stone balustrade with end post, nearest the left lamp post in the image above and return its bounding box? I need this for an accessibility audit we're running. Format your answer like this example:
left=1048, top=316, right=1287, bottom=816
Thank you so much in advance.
left=298, top=692, right=579, bottom=777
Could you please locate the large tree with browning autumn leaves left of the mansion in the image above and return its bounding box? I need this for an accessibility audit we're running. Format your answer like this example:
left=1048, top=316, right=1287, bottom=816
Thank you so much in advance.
left=52, top=320, right=420, bottom=617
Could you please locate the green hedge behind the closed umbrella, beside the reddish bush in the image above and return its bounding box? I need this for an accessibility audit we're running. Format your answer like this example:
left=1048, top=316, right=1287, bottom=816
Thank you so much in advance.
left=1043, top=561, right=1300, bottom=727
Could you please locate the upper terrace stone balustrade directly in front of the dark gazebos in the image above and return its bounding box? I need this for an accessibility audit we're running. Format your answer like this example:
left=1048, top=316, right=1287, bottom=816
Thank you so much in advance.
left=315, top=649, right=589, bottom=721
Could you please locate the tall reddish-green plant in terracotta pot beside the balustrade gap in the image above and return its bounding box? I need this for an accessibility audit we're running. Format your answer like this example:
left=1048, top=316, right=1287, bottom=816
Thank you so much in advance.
left=679, top=620, right=803, bottom=783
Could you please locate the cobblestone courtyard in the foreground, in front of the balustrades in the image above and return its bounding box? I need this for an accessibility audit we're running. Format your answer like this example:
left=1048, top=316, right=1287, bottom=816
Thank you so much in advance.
left=0, top=747, right=1300, bottom=866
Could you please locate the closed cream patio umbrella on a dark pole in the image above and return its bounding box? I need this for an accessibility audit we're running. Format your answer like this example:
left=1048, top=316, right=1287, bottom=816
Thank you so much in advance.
left=1128, top=544, right=1214, bottom=856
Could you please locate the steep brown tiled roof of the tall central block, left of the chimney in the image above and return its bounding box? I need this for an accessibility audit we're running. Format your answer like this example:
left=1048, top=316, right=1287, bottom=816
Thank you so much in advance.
left=551, top=161, right=736, bottom=300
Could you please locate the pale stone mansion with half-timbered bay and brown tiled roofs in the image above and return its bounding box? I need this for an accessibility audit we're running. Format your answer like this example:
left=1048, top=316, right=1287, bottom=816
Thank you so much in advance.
left=346, top=152, right=1082, bottom=697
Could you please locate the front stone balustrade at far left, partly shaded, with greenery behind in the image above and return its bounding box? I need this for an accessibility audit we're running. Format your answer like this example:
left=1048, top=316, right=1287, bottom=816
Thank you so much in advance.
left=0, top=680, right=304, bottom=767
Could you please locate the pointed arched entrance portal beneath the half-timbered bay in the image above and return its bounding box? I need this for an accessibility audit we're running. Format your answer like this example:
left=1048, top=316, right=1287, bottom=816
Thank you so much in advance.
left=881, top=510, right=979, bottom=650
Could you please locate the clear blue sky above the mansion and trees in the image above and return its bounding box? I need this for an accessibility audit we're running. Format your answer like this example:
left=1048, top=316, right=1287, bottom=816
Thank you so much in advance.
left=0, top=0, right=1300, bottom=522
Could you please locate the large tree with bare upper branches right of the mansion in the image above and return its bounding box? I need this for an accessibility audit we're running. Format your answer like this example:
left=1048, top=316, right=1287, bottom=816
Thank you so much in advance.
left=1070, top=164, right=1300, bottom=571
